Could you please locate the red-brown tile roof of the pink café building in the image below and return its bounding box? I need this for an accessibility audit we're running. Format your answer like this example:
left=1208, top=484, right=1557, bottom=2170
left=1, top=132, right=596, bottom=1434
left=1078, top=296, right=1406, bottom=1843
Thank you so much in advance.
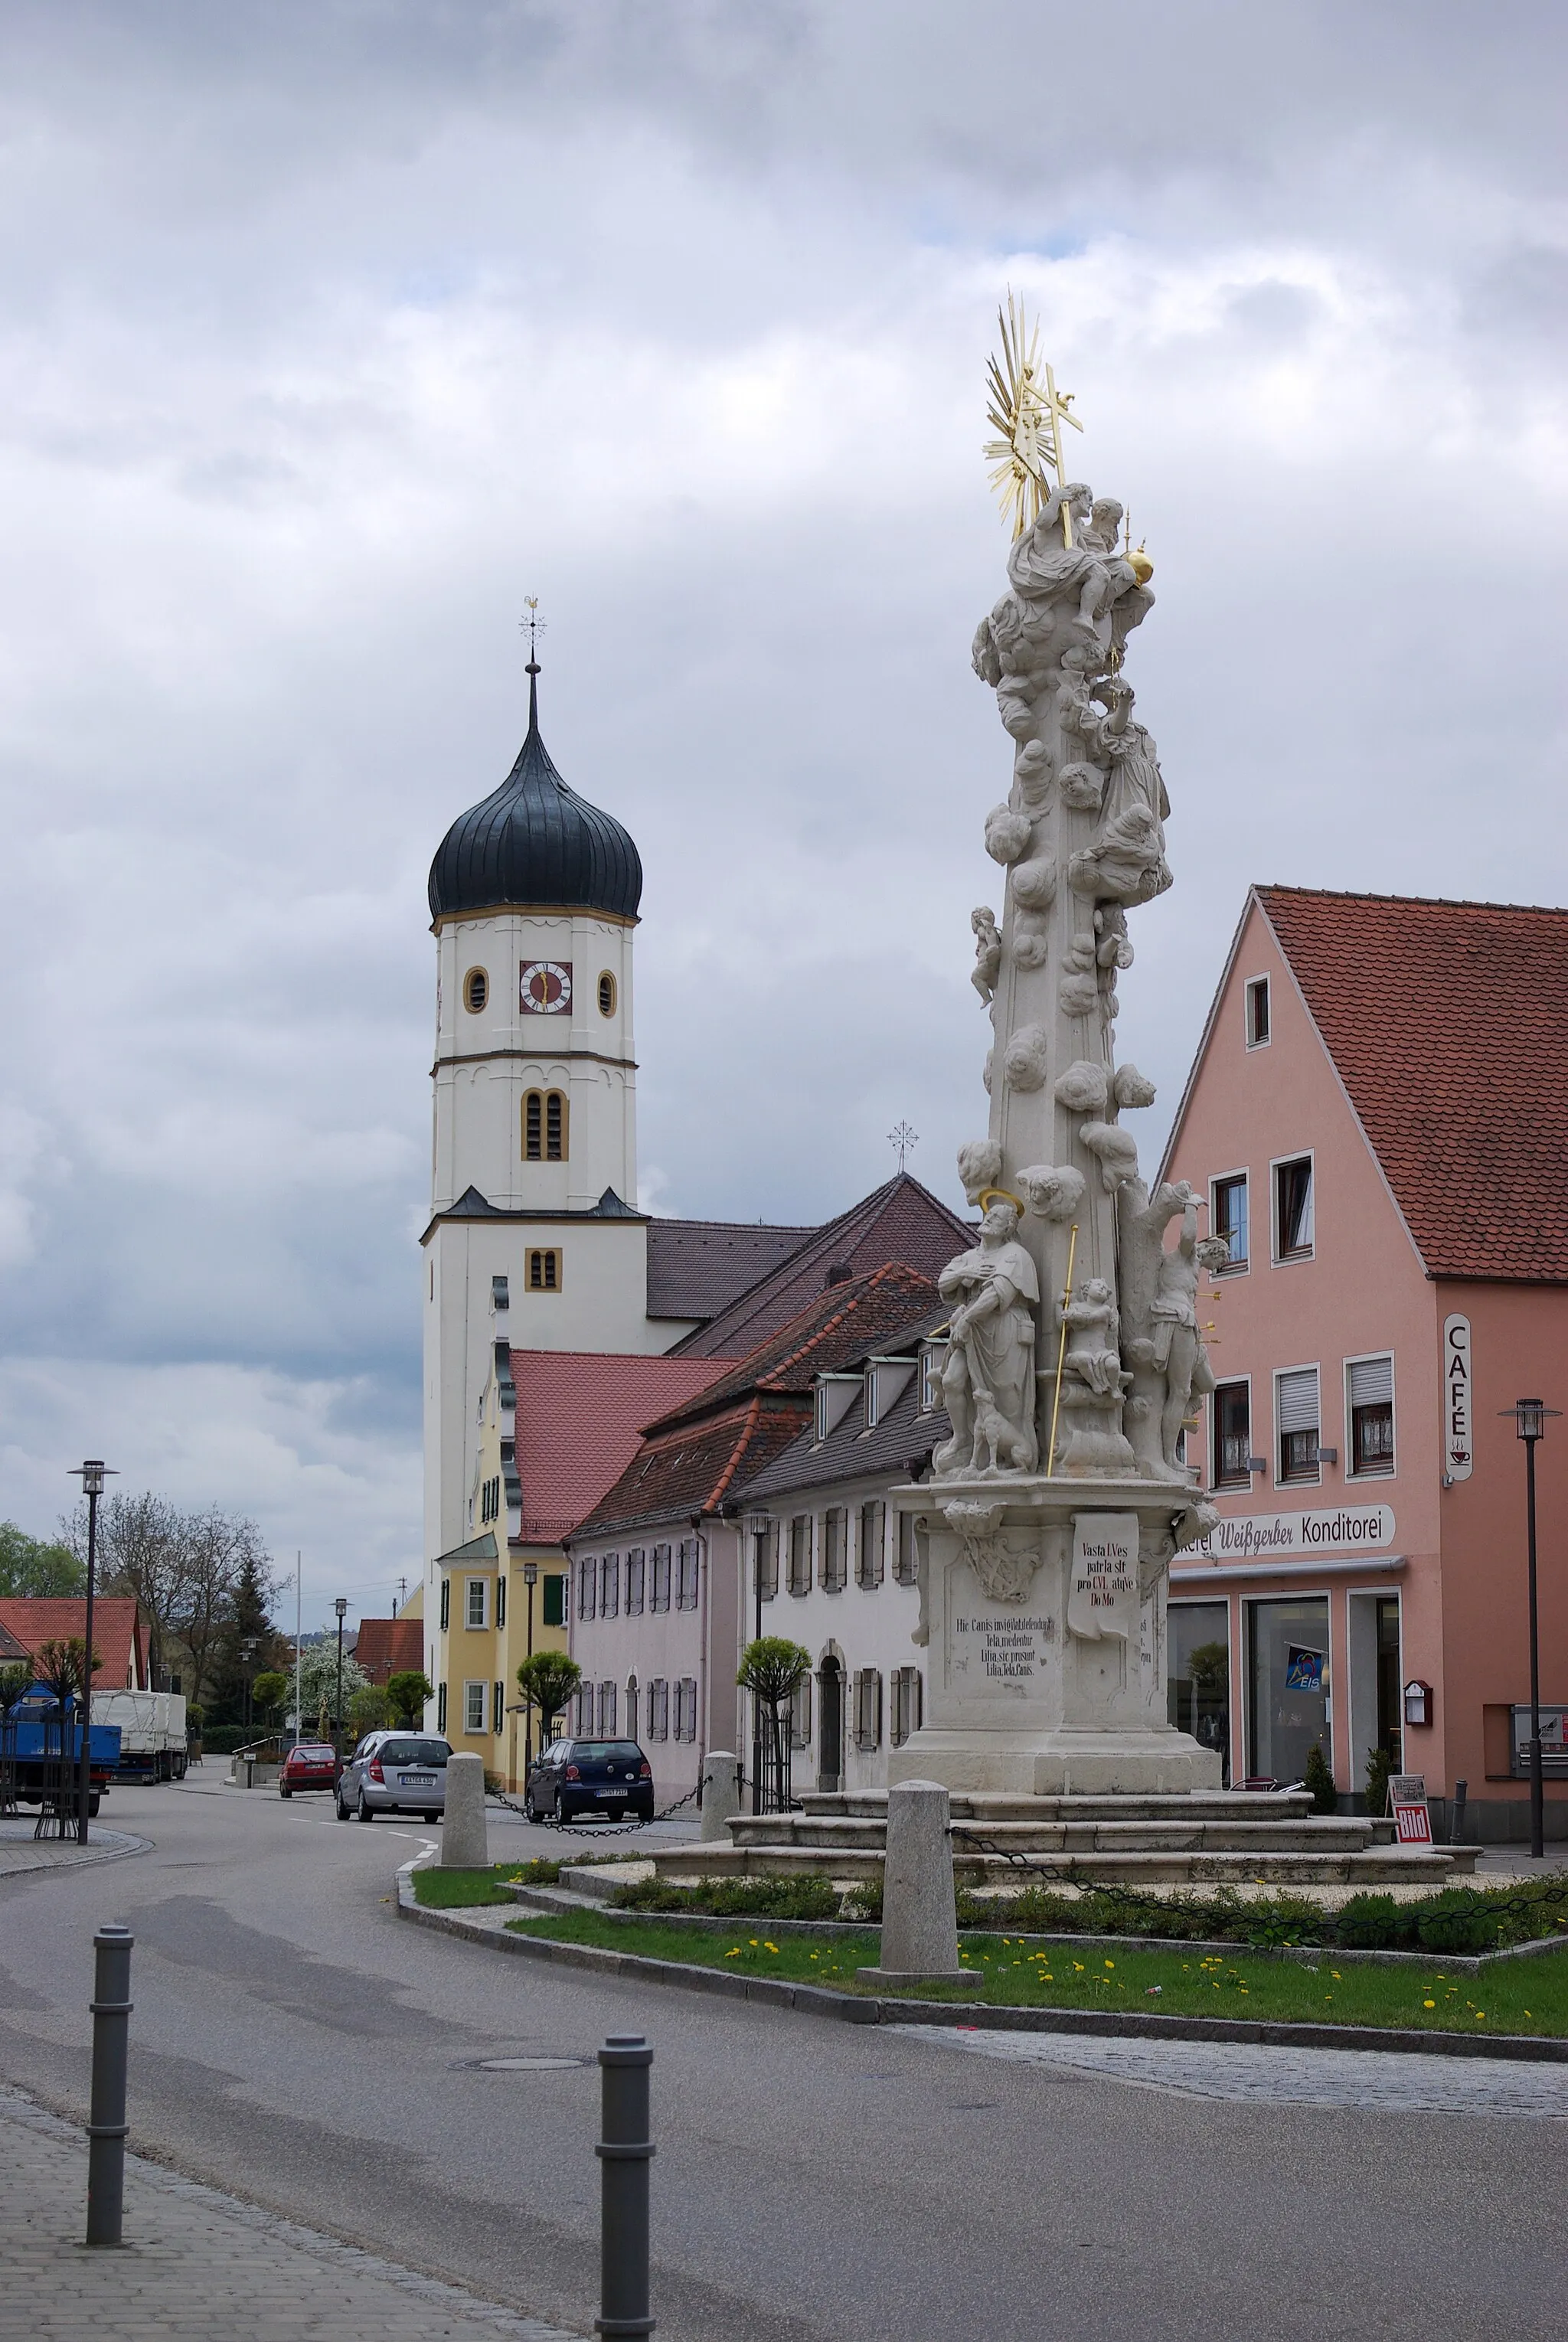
left=1256, top=885, right=1568, bottom=1283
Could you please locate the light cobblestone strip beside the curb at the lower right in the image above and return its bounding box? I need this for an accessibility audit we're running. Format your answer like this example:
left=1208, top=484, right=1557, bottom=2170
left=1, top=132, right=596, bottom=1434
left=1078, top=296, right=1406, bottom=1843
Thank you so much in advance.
left=888, top=2026, right=1568, bottom=2122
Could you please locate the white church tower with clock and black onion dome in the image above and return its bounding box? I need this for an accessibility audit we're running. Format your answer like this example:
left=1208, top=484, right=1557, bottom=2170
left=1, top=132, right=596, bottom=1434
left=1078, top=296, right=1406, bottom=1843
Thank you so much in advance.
left=422, top=658, right=680, bottom=1560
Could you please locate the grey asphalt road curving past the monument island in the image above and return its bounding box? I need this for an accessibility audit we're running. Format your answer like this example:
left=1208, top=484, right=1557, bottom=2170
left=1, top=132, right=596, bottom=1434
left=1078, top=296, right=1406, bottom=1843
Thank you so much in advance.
left=0, top=1782, right=1563, bottom=2342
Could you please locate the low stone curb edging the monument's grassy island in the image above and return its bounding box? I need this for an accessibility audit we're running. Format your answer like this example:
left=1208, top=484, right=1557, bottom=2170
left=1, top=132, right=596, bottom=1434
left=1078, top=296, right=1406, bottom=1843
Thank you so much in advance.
left=396, top=1862, right=1568, bottom=2066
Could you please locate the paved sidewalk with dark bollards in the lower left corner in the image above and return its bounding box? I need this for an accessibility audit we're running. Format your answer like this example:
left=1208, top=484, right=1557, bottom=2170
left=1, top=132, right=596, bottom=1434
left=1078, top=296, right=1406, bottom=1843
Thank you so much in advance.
left=0, top=2089, right=581, bottom=2342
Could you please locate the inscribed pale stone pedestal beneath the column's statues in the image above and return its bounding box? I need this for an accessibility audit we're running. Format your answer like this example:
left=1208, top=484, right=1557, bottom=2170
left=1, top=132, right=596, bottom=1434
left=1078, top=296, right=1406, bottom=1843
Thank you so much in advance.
left=888, top=1473, right=1221, bottom=1796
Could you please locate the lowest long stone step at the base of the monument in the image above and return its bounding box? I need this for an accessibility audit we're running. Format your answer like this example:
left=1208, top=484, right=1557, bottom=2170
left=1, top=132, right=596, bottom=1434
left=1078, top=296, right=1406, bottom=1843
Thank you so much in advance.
left=652, top=1843, right=1479, bottom=1893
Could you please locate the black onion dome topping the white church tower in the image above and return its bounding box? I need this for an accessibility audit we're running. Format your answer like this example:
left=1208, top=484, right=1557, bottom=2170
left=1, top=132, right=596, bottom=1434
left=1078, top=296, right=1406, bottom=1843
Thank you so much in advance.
left=429, top=668, right=642, bottom=918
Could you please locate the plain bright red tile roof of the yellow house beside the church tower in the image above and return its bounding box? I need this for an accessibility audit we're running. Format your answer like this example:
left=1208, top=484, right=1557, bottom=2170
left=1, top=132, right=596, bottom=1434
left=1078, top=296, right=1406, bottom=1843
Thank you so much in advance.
left=511, top=1349, right=729, bottom=1546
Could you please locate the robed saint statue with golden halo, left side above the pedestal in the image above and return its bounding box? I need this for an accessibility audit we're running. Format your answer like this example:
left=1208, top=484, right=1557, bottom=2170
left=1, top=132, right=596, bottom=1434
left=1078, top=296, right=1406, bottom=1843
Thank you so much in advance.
left=935, top=1197, right=1040, bottom=1473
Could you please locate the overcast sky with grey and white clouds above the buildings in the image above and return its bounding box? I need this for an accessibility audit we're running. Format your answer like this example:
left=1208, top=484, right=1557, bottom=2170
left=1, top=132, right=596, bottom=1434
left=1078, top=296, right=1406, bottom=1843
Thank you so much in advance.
left=0, top=0, right=1568, bottom=1623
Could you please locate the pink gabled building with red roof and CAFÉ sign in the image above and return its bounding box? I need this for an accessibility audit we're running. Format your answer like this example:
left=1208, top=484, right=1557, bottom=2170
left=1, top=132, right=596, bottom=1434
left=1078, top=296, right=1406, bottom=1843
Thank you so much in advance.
left=1165, top=885, right=1568, bottom=1838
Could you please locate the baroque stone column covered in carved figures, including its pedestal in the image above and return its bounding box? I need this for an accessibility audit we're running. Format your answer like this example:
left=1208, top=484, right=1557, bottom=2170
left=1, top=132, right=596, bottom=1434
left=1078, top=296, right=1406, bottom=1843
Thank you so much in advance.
left=888, top=485, right=1223, bottom=1794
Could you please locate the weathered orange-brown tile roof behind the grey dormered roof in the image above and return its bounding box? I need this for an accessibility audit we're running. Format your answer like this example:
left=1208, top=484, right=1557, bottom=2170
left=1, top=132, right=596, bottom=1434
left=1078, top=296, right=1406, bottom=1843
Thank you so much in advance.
left=577, top=1260, right=938, bottom=1537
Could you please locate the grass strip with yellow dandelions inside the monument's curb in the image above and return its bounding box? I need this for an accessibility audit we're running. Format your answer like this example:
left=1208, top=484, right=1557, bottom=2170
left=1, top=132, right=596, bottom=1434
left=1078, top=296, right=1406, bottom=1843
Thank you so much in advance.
left=501, top=1911, right=1568, bottom=2033
